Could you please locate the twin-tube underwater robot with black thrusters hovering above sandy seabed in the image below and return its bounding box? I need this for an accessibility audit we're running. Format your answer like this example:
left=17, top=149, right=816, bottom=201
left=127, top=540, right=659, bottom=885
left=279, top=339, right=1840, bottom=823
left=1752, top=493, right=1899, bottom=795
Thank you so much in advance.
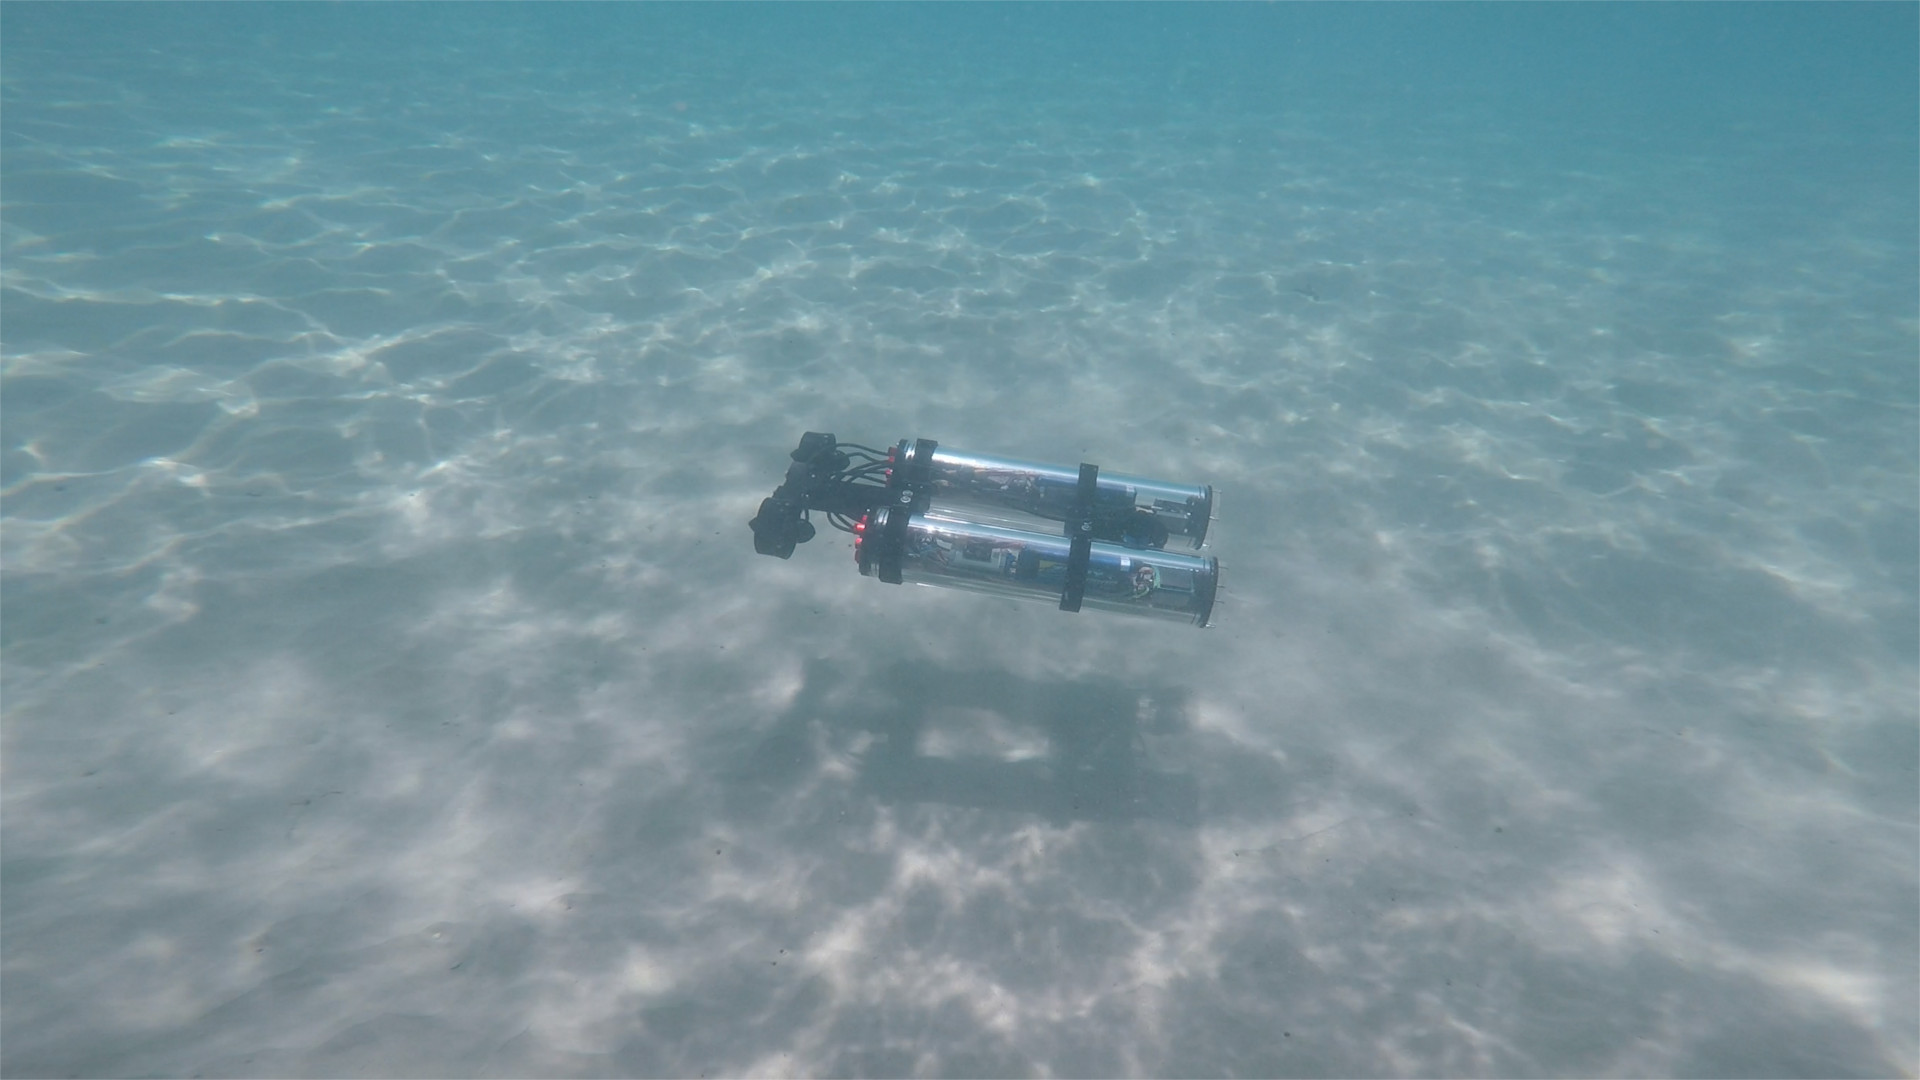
left=747, top=430, right=1219, bottom=626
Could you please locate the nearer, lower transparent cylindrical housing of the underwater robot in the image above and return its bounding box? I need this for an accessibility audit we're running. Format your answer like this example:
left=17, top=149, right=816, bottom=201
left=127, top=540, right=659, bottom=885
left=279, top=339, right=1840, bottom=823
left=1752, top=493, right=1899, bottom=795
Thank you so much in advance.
left=854, top=511, right=1219, bottom=626
